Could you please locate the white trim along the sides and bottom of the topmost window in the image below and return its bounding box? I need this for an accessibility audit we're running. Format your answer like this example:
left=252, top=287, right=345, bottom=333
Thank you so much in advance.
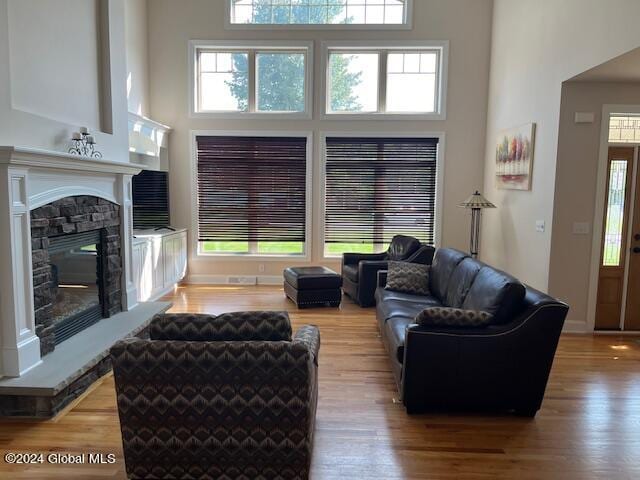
left=224, top=0, right=413, bottom=30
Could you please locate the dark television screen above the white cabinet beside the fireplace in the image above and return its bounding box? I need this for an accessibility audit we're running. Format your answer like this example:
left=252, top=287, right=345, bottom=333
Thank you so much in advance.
left=132, top=170, right=169, bottom=228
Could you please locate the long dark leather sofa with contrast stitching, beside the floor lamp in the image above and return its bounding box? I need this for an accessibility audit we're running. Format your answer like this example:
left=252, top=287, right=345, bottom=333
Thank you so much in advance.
left=376, top=248, right=569, bottom=416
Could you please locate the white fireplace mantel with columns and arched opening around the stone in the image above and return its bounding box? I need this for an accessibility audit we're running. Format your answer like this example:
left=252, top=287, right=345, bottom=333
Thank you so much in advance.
left=0, top=146, right=144, bottom=377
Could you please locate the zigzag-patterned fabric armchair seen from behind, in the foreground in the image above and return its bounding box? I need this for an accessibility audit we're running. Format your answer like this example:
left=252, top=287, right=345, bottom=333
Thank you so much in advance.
left=111, top=312, right=320, bottom=479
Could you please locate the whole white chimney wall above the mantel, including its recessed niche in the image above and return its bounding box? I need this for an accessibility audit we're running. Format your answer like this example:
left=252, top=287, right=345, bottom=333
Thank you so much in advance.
left=0, top=0, right=129, bottom=162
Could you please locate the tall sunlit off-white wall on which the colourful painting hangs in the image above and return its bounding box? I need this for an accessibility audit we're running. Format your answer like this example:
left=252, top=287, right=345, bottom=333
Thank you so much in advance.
left=481, top=0, right=640, bottom=293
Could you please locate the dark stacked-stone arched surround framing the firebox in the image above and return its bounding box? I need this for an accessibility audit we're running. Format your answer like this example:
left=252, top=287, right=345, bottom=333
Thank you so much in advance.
left=30, top=195, right=122, bottom=356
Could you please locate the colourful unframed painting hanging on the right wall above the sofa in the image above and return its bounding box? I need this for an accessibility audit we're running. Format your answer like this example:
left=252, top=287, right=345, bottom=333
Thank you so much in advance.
left=496, top=123, right=536, bottom=190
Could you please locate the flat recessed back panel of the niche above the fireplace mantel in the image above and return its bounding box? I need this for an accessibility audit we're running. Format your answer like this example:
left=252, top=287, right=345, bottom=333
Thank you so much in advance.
left=8, top=0, right=102, bottom=130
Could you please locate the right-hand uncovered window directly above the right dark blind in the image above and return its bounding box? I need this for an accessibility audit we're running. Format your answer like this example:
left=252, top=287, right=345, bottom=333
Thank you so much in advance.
left=325, top=42, right=447, bottom=119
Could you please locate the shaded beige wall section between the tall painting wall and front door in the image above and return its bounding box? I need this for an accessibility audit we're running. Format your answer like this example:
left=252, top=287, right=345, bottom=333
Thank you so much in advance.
left=549, top=82, right=640, bottom=329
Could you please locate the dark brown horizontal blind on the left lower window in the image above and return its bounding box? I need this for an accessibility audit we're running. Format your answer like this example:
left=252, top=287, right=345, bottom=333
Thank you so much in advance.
left=196, top=136, right=307, bottom=242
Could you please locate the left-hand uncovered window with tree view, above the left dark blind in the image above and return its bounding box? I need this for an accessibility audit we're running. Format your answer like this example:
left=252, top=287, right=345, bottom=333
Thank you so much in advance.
left=192, top=43, right=311, bottom=118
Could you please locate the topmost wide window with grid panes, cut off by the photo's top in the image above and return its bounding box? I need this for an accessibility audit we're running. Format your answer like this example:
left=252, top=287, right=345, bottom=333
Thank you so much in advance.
left=227, top=0, right=411, bottom=28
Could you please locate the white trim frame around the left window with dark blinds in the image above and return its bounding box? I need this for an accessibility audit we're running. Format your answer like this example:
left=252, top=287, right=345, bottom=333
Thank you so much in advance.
left=190, top=130, right=313, bottom=262
